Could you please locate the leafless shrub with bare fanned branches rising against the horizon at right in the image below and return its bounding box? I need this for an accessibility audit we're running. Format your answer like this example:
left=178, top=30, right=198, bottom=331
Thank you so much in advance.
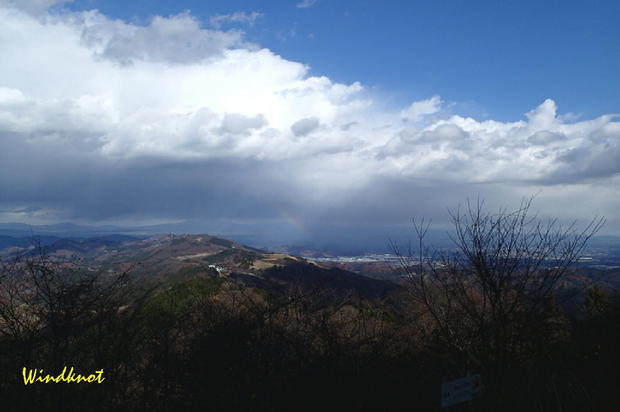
left=393, top=198, right=604, bottom=374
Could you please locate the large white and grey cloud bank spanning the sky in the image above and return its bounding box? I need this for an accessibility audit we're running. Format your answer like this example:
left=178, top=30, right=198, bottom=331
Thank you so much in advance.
left=0, top=0, right=620, bottom=238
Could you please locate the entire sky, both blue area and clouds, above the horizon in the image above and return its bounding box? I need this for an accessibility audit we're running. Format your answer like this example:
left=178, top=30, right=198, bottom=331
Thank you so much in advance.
left=0, top=0, right=620, bottom=248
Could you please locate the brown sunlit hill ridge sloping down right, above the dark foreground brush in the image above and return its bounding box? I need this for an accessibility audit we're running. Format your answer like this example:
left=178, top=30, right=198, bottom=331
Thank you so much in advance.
left=0, top=232, right=399, bottom=298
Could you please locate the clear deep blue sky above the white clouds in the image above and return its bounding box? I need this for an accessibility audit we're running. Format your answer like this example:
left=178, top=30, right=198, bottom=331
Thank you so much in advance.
left=61, top=0, right=620, bottom=121
